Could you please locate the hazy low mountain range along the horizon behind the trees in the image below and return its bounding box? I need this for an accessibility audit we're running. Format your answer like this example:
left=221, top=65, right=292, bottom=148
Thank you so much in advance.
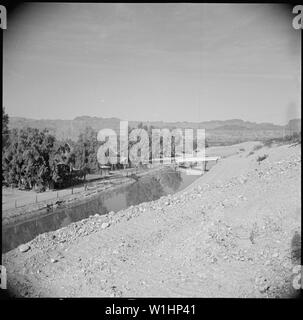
left=9, top=116, right=301, bottom=145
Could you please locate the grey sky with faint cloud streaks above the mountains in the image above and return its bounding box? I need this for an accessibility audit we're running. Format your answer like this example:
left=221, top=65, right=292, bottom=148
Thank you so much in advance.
left=3, top=3, right=301, bottom=124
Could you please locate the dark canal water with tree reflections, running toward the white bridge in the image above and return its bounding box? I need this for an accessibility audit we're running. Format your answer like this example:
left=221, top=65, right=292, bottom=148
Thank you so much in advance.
left=2, top=167, right=198, bottom=252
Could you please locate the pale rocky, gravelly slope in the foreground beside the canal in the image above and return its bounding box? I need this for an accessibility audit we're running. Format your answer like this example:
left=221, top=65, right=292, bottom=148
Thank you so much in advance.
left=2, top=144, right=301, bottom=298
